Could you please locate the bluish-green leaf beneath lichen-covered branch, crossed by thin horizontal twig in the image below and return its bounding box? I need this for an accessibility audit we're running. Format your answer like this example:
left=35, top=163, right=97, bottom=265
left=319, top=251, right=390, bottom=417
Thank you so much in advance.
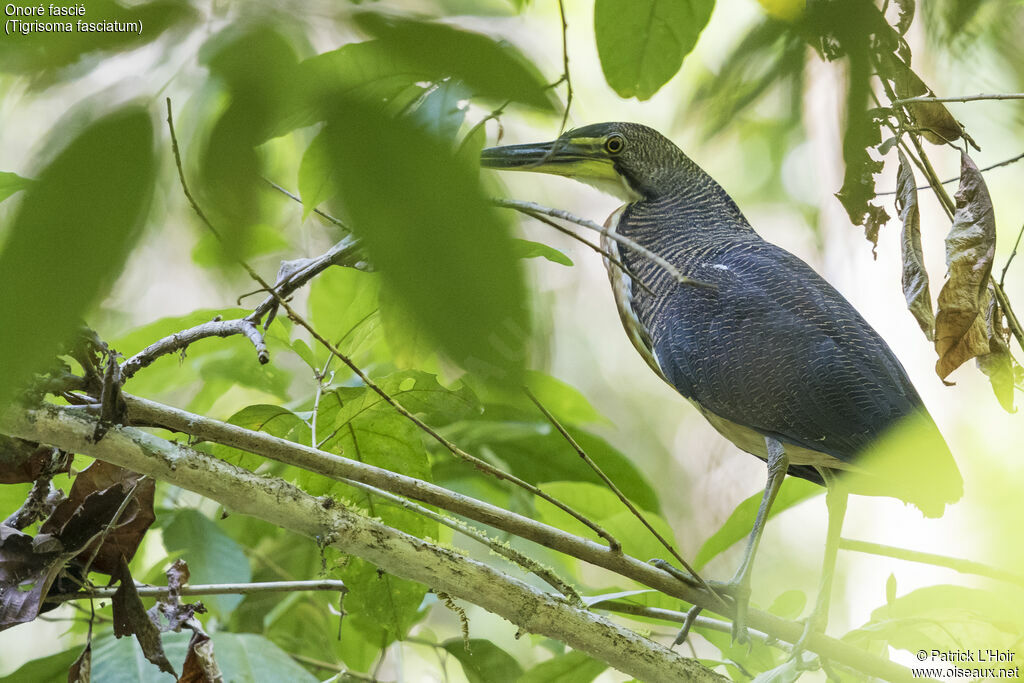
left=163, top=509, right=252, bottom=616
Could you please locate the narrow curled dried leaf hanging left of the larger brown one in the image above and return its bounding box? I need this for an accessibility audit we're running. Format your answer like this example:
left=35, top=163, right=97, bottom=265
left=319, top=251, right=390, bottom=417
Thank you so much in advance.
left=896, top=150, right=935, bottom=341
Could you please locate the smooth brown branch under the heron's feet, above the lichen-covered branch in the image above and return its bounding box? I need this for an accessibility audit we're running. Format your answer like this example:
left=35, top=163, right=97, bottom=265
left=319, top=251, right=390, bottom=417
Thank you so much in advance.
left=99, top=394, right=925, bottom=681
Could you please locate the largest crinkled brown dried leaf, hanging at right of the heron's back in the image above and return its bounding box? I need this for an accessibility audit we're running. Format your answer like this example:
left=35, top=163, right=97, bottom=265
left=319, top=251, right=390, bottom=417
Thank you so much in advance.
left=935, top=154, right=995, bottom=379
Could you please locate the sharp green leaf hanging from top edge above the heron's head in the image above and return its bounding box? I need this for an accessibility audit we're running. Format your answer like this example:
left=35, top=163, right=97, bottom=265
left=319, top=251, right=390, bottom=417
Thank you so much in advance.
left=594, top=0, right=715, bottom=99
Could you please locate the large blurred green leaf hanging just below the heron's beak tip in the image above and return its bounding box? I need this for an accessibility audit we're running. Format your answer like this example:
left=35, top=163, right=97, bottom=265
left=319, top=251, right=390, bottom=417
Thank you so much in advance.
left=328, top=100, right=529, bottom=379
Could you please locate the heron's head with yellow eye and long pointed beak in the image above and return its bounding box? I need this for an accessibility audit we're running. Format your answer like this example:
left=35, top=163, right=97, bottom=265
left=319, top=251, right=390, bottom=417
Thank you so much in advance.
left=480, top=123, right=689, bottom=202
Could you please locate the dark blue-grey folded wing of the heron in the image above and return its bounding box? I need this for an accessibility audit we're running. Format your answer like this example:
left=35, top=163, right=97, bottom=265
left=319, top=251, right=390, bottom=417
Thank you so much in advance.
left=651, top=240, right=923, bottom=462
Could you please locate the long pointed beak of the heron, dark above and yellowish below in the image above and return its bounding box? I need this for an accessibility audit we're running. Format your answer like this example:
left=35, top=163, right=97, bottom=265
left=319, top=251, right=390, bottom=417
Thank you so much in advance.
left=480, top=137, right=617, bottom=179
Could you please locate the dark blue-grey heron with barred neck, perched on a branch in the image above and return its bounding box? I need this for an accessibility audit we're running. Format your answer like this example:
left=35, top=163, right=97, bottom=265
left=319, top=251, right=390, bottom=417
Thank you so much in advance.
left=481, top=123, right=963, bottom=652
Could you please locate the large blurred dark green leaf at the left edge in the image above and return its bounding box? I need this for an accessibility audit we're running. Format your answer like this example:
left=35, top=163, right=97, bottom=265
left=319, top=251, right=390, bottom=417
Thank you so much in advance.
left=0, top=106, right=156, bottom=403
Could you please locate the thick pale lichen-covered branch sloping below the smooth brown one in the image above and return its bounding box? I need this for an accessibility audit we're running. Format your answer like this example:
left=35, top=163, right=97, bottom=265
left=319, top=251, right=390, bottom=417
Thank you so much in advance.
left=6, top=408, right=729, bottom=682
